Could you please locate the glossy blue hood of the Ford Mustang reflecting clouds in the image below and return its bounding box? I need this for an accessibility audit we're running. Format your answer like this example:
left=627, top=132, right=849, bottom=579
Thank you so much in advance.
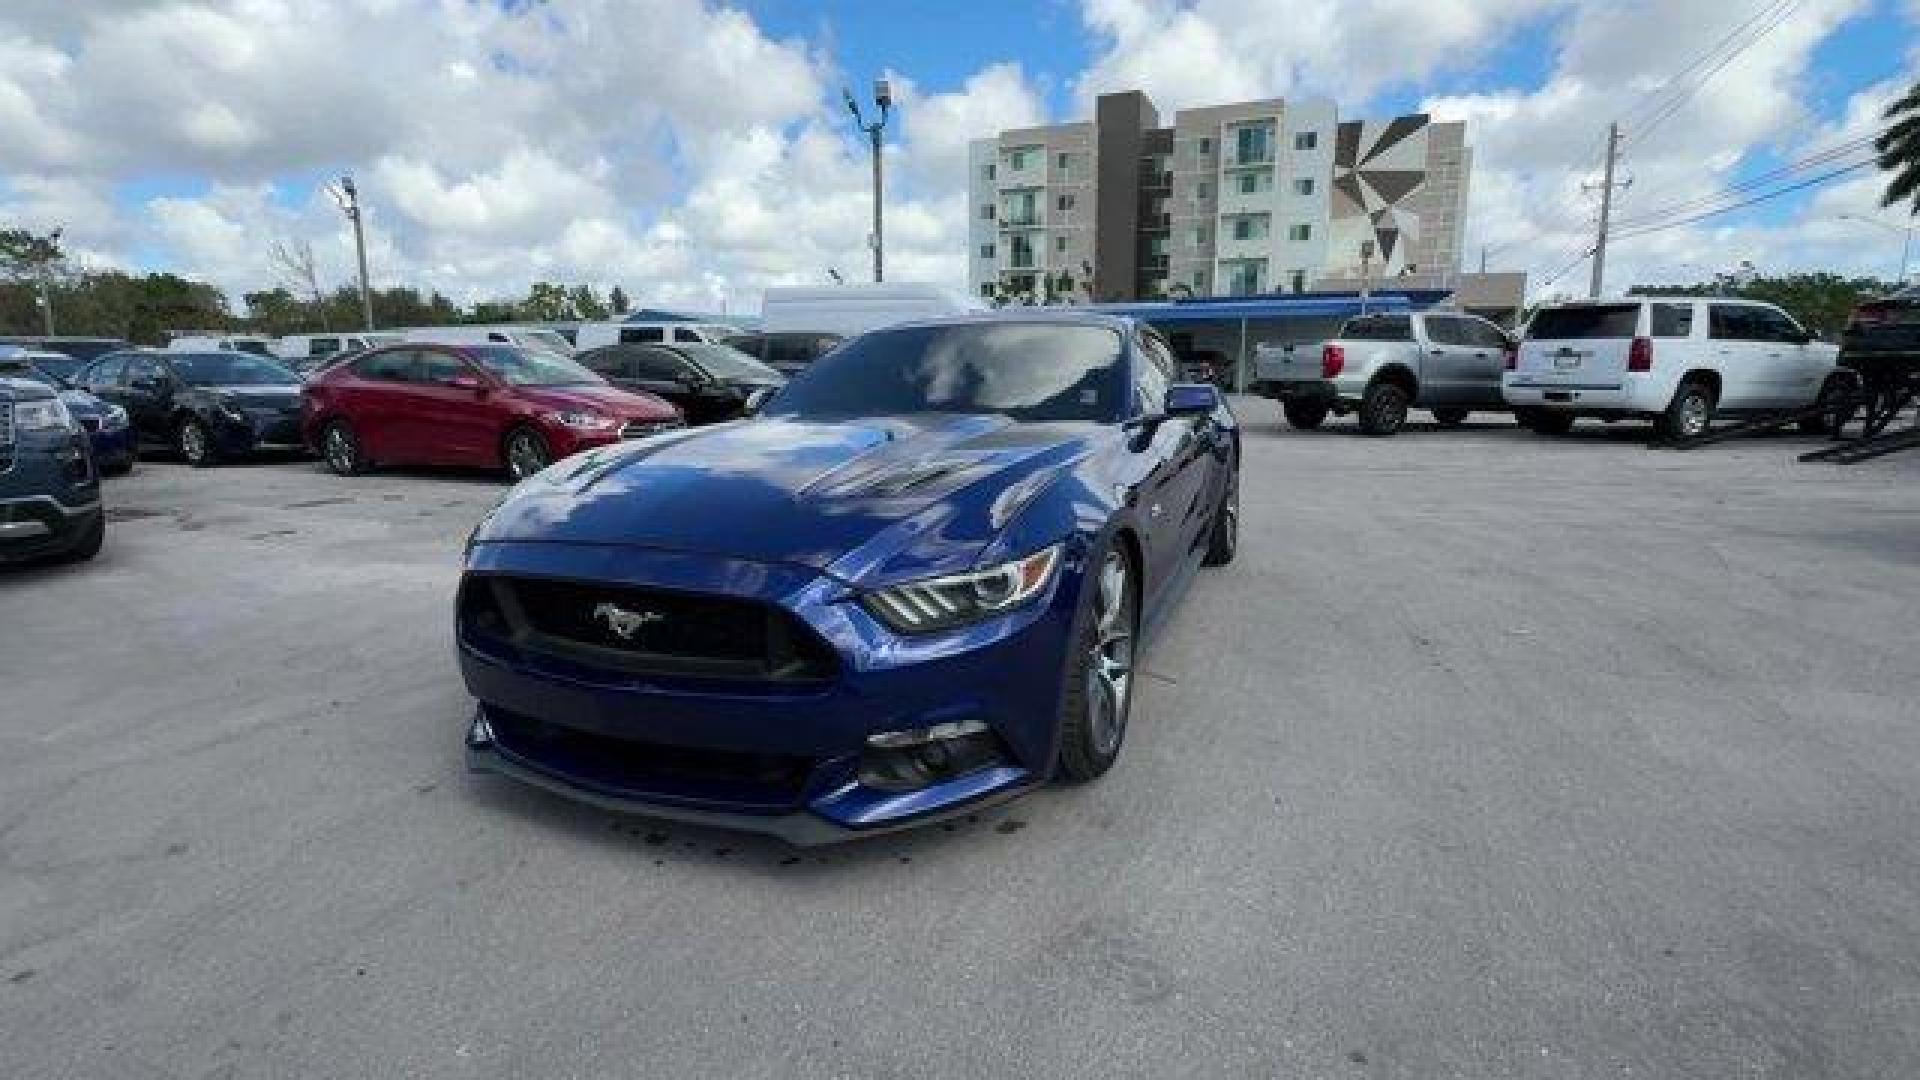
left=476, top=415, right=1100, bottom=580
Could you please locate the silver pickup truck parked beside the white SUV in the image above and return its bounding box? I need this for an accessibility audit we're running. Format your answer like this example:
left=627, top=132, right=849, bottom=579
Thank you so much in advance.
left=1252, top=311, right=1515, bottom=436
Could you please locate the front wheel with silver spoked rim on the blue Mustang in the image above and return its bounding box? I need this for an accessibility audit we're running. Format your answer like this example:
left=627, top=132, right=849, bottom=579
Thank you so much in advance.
left=1054, top=544, right=1140, bottom=784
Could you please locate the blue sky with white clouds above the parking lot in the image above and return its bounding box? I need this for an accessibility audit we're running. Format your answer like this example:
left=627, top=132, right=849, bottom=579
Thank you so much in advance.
left=0, top=0, right=1920, bottom=311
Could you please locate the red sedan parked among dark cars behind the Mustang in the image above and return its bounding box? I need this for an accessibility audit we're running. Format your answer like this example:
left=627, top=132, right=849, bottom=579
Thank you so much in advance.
left=301, top=342, right=684, bottom=480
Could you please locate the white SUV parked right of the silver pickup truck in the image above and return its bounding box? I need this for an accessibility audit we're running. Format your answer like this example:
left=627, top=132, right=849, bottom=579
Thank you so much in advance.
left=1501, top=296, right=1843, bottom=438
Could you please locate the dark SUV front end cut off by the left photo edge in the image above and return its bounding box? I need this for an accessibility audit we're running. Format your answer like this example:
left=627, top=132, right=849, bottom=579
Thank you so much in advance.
left=0, top=379, right=106, bottom=563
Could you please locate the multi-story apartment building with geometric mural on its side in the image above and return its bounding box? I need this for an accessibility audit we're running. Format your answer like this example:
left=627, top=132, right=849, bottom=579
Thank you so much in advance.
left=968, top=90, right=1473, bottom=300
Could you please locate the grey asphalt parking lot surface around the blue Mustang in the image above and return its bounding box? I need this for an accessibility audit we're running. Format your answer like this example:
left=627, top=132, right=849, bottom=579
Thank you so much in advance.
left=0, top=402, right=1920, bottom=1078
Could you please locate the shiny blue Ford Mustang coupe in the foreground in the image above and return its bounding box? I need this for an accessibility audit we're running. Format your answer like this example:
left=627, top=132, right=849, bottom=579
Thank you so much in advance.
left=455, top=313, right=1240, bottom=844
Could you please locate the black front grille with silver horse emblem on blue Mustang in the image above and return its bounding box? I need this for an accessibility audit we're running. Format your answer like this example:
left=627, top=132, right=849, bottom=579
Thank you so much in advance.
left=459, top=575, right=837, bottom=684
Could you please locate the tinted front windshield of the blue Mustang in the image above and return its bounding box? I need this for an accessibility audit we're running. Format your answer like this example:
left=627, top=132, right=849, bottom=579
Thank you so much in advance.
left=766, top=323, right=1125, bottom=423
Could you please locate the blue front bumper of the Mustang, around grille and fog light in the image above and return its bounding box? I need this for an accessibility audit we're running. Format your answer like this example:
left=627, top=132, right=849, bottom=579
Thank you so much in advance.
left=457, top=544, right=1079, bottom=844
